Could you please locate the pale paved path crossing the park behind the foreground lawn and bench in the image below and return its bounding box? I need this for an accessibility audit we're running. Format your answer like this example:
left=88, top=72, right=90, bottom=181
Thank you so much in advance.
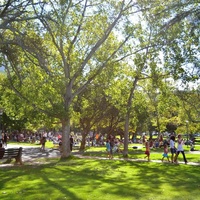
left=0, top=144, right=200, bottom=167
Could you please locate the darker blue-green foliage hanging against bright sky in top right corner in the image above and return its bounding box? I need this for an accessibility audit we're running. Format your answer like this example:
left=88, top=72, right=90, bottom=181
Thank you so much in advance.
left=143, top=0, right=200, bottom=82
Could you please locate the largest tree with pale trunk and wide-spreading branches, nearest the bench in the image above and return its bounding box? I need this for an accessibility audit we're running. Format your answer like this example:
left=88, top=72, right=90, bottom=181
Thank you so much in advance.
left=0, top=0, right=145, bottom=157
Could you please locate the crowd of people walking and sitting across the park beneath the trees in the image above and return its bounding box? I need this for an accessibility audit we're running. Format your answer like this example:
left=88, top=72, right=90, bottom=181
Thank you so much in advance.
left=0, top=132, right=194, bottom=164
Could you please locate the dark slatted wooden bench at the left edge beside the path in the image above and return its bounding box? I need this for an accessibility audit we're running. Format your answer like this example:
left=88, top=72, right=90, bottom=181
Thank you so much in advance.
left=0, top=147, right=22, bottom=165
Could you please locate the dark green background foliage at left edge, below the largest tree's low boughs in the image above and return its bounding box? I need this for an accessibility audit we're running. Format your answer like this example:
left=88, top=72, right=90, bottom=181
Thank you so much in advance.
left=0, top=74, right=59, bottom=131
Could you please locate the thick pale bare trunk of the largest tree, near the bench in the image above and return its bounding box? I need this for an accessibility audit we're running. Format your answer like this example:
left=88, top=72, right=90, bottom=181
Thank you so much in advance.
left=61, top=119, right=71, bottom=158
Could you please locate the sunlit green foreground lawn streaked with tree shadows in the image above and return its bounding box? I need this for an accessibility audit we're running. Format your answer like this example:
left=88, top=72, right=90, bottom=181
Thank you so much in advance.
left=0, top=158, right=200, bottom=200
